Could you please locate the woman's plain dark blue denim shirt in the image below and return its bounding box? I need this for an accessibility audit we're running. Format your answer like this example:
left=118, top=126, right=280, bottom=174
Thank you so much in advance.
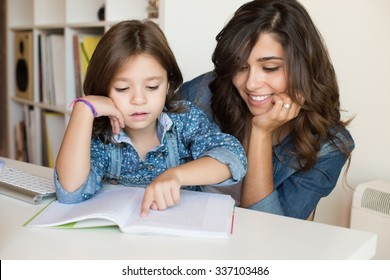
left=179, top=72, right=355, bottom=219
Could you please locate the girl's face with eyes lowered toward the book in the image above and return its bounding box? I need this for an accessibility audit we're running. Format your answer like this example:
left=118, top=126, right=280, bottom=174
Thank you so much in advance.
left=109, top=54, right=169, bottom=134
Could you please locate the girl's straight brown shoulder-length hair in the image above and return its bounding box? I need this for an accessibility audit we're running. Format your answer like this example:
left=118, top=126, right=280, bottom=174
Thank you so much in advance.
left=83, top=20, right=184, bottom=142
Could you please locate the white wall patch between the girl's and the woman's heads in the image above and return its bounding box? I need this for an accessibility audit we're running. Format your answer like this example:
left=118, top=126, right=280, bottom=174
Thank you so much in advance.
left=160, top=0, right=247, bottom=81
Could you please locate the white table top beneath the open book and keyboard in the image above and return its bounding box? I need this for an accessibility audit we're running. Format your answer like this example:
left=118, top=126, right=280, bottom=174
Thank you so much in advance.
left=0, top=158, right=377, bottom=260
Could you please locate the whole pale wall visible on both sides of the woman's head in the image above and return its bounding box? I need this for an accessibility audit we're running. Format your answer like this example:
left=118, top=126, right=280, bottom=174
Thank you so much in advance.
left=160, top=0, right=390, bottom=226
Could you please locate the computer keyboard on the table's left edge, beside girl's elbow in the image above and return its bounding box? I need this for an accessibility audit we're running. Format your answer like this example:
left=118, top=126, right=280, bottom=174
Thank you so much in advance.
left=0, top=167, right=55, bottom=204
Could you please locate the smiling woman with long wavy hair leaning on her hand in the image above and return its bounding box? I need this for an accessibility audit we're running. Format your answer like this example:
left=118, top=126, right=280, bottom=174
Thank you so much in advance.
left=181, top=0, right=354, bottom=219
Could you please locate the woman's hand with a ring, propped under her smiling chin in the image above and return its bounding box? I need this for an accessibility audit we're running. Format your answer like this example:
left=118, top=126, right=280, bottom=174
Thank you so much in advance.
left=252, top=93, right=303, bottom=132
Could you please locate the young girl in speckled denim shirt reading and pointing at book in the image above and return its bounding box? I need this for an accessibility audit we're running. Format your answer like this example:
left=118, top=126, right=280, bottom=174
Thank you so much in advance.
left=54, top=20, right=246, bottom=215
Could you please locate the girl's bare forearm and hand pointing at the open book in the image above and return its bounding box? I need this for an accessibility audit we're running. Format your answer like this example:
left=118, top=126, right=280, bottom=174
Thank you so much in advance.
left=141, top=157, right=231, bottom=216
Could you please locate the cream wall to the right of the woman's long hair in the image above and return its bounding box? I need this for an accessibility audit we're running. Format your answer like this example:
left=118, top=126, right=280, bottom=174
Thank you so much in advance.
left=302, top=0, right=390, bottom=226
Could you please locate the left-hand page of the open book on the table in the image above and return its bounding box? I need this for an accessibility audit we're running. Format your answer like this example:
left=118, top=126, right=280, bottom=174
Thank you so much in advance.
left=27, top=186, right=144, bottom=227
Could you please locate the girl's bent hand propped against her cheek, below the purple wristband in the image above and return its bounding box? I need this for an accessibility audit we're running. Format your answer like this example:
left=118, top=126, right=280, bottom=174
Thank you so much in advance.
left=83, top=95, right=125, bottom=134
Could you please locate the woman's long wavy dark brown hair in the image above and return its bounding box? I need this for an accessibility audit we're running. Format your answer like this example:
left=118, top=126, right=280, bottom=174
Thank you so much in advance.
left=210, top=0, right=350, bottom=171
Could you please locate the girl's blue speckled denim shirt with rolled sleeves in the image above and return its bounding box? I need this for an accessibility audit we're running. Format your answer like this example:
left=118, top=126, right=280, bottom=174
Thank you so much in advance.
left=54, top=101, right=247, bottom=203
